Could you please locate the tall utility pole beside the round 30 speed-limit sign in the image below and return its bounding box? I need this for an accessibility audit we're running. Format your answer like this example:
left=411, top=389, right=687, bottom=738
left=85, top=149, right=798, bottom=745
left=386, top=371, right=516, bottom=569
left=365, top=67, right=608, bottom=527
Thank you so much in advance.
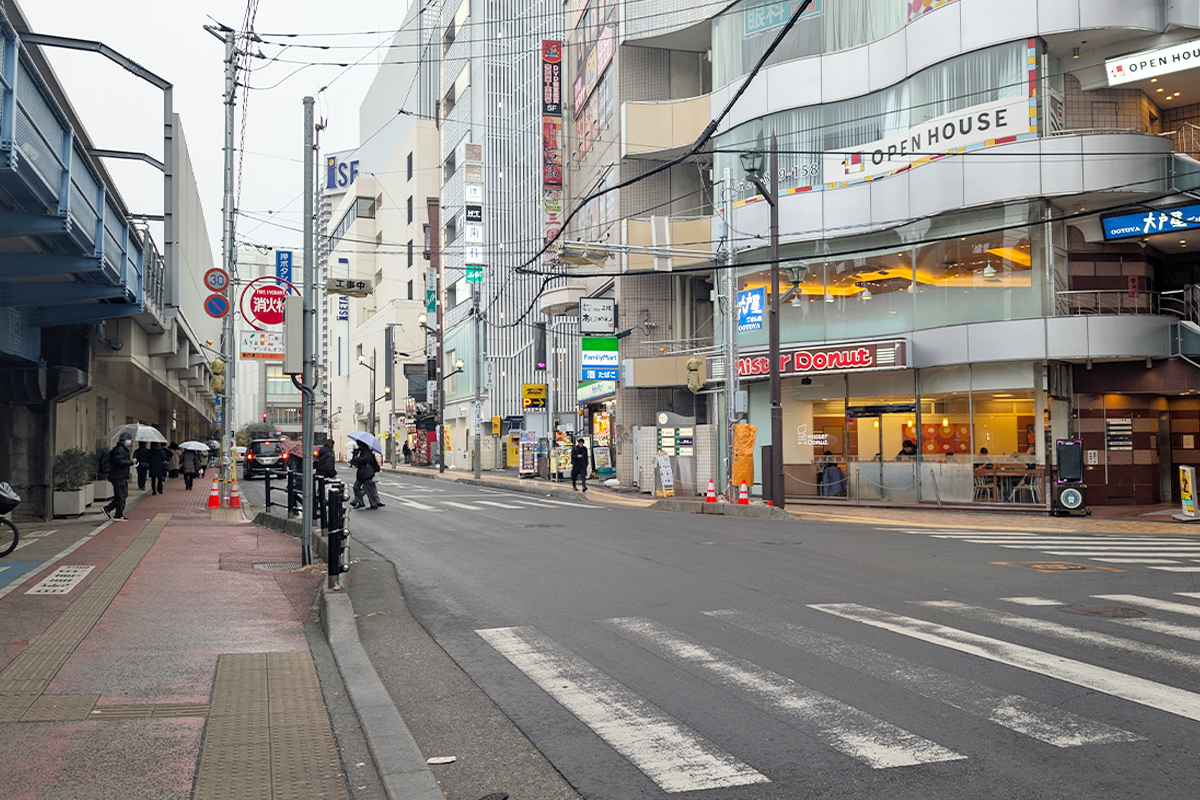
left=221, top=30, right=238, bottom=495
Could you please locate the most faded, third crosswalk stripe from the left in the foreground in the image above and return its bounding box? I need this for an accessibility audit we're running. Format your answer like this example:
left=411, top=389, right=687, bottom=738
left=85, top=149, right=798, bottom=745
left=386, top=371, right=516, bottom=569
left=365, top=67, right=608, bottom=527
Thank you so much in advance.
left=704, top=610, right=1142, bottom=747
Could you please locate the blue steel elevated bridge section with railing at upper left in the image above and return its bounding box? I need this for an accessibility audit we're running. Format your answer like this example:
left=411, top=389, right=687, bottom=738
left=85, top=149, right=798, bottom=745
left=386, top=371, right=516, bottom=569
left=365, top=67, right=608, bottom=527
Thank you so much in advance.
left=0, top=8, right=164, bottom=366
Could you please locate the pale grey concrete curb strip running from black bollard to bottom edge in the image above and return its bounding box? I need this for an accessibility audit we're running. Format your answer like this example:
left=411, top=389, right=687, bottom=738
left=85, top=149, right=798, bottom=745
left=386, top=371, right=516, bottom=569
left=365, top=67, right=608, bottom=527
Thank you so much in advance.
left=320, top=591, right=445, bottom=800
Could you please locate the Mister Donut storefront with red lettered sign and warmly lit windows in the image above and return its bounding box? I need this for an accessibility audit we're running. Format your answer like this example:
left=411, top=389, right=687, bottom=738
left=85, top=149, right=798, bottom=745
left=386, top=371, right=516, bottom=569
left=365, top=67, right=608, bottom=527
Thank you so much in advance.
left=715, top=337, right=1067, bottom=506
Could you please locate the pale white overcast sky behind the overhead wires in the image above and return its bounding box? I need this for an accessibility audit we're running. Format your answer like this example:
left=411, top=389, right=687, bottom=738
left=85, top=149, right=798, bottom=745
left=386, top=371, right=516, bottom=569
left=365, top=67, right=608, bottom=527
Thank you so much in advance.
left=18, top=0, right=408, bottom=263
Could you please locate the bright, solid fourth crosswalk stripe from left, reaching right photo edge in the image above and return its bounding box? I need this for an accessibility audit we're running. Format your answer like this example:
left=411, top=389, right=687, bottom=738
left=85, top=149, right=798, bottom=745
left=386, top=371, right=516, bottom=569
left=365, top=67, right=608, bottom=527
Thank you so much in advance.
left=809, top=603, right=1200, bottom=720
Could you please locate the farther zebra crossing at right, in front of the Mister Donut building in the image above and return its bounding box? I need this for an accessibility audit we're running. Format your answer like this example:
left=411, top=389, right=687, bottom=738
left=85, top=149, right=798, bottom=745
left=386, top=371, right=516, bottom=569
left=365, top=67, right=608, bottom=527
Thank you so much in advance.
left=880, top=528, right=1200, bottom=572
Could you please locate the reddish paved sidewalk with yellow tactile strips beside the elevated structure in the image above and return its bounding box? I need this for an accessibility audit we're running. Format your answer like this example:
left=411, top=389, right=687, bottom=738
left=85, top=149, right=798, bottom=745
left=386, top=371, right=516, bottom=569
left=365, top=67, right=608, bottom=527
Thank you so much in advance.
left=0, top=480, right=349, bottom=800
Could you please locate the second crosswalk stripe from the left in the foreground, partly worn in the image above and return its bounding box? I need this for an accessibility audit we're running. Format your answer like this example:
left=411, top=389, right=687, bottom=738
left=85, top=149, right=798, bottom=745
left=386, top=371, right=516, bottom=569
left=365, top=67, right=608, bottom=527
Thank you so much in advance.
left=602, top=618, right=966, bottom=769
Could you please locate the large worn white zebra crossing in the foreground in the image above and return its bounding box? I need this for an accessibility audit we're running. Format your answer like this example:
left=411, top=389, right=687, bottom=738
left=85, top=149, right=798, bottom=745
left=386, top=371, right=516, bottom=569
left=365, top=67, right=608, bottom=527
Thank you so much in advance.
left=476, top=593, right=1200, bottom=793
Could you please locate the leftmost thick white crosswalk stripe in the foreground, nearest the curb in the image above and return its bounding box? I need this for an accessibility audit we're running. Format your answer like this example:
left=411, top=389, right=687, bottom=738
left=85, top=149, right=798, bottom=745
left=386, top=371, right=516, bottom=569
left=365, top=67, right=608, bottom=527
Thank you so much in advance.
left=476, top=627, right=769, bottom=792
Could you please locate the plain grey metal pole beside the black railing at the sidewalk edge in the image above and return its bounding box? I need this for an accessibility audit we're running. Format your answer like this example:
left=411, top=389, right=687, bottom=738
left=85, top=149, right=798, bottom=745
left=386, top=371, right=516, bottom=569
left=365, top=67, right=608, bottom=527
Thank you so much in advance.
left=300, top=97, right=317, bottom=565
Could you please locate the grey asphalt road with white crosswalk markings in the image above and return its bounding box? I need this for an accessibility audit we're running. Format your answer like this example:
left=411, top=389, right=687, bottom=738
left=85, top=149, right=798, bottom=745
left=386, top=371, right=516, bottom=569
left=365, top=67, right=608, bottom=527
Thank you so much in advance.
left=238, top=475, right=1200, bottom=800
